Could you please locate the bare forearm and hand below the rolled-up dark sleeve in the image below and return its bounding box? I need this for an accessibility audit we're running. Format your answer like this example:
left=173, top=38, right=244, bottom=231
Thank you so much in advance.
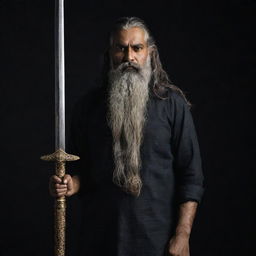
left=168, top=201, right=198, bottom=256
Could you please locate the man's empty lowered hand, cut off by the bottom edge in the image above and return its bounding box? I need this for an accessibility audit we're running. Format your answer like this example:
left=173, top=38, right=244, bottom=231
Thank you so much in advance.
left=168, top=234, right=190, bottom=256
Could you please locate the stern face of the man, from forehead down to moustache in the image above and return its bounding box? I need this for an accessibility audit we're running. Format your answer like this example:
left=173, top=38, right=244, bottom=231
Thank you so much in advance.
left=110, top=27, right=149, bottom=69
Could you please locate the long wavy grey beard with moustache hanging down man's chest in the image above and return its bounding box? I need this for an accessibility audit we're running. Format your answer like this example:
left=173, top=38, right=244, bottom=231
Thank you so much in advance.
left=108, top=56, right=152, bottom=196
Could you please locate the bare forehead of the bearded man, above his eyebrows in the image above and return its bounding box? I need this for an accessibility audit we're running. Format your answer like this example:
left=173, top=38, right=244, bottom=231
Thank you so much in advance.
left=113, top=27, right=146, bottom=45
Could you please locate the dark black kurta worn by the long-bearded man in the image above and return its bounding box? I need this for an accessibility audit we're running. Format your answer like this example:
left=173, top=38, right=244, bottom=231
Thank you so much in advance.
left=70, top=86, right=203, bottom=256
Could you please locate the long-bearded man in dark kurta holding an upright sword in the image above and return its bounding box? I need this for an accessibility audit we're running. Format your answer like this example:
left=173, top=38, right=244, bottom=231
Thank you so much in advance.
left=50, top=17, right=203, bottom=256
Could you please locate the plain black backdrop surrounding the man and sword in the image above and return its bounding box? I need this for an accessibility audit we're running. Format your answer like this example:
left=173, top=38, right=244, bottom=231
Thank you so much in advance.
left=0, top=0, right=256, bottom=256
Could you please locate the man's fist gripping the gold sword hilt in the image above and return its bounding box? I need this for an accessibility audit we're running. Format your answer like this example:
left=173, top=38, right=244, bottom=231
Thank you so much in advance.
left=49, top=174, right=78, bottom=197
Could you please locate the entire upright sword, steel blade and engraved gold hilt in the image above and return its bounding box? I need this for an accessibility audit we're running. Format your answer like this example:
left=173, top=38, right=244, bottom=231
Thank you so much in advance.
left=41, top=0, right=79, bottom=256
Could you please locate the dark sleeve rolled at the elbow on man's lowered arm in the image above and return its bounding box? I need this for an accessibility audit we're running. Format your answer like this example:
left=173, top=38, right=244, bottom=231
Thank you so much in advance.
left=169, top=92, right=204, bottom=203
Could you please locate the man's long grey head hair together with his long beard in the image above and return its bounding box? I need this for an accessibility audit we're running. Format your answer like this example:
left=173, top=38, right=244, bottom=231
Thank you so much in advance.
left=104, top=17, right=189, bottom=196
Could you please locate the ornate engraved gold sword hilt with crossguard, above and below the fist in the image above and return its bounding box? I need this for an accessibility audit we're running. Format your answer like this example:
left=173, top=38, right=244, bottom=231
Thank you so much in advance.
left=41, top=149, right=79, bottom=256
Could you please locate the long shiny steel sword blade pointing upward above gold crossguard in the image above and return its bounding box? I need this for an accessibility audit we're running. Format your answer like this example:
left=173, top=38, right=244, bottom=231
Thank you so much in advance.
left=55, top=0, right=65, bottom=151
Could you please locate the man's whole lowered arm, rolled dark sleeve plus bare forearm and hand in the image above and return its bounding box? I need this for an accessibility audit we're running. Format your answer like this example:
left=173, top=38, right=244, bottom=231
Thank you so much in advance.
left=168, top=94, right=204, bottom=256
